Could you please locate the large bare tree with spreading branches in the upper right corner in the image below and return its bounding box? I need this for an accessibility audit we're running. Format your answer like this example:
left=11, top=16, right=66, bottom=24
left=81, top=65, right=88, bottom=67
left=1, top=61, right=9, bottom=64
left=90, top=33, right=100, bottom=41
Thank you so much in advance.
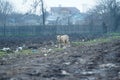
left=86, top=0, right=120, bottom=32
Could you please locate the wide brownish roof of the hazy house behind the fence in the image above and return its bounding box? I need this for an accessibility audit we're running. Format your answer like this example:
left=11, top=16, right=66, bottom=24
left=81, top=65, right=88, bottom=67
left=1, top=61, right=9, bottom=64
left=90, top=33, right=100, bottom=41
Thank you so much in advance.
left=51, top=7, right=80, bottom=14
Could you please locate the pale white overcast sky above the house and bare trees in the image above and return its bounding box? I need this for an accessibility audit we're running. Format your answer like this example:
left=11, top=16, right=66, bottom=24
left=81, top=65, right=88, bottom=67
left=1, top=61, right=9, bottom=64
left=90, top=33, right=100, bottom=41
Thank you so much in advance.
left=8, top=0, right=95, bottom=13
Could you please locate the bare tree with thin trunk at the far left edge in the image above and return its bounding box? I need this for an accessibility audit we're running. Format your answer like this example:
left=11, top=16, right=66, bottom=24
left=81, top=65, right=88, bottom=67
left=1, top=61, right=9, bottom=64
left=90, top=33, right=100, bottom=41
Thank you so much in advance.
left=0, top=0, right=13, bottom=36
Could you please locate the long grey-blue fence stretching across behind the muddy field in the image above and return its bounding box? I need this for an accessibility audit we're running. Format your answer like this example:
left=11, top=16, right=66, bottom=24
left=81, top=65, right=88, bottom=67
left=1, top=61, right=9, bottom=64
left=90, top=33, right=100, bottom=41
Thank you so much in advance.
left=0, top=25, right=102, bottom=36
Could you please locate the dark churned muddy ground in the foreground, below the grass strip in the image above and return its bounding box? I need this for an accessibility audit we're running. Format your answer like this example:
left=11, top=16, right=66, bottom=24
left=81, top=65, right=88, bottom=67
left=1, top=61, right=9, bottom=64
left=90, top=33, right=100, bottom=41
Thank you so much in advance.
left=0, top=40, right=120, bottom=80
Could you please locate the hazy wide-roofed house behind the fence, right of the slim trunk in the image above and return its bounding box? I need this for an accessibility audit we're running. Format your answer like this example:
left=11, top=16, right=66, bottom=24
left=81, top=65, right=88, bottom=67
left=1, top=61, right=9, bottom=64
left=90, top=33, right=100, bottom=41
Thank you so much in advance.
left=46, top=7, right=85, bottom=25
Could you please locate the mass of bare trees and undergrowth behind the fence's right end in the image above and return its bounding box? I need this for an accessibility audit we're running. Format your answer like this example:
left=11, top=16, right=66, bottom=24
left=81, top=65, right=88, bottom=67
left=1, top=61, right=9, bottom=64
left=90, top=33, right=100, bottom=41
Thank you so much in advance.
left=87, top=0, right=120, bottom=33
